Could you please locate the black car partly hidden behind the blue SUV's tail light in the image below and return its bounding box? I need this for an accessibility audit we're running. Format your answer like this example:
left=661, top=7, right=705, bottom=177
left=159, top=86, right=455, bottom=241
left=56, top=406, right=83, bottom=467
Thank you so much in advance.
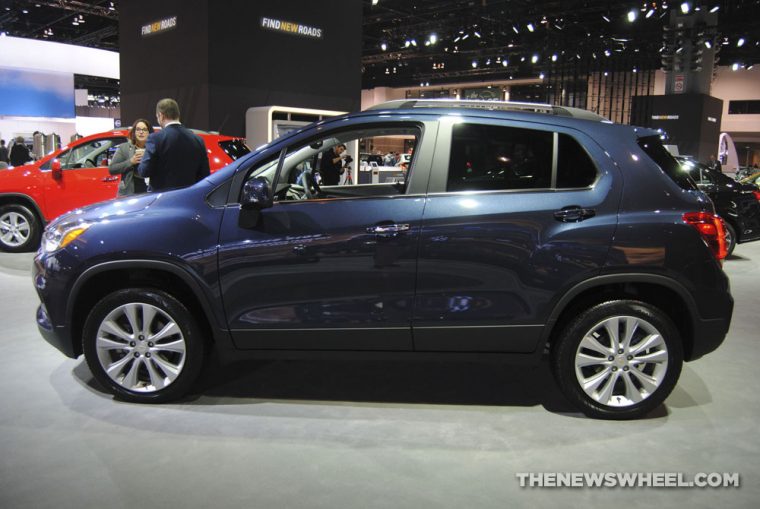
left=676, top=157, right=760, bottom=254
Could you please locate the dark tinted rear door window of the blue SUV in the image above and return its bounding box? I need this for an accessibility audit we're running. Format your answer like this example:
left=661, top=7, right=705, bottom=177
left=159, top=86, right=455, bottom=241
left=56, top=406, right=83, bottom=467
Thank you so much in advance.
left=447, top=124, right=553, bottom=191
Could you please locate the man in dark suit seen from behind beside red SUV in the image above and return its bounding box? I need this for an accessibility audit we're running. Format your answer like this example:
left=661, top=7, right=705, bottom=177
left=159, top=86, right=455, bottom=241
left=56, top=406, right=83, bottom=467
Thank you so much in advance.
left=137, top=99, right=210, bottom=192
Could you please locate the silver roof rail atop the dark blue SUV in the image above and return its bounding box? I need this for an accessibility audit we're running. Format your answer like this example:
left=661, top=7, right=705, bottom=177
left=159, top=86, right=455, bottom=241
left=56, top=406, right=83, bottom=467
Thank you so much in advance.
left=367, top=99, right=609, bottom=122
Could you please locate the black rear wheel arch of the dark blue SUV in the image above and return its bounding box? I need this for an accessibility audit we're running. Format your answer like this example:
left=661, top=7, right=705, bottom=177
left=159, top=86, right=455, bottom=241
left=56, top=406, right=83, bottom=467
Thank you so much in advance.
left=542, top=274, right=697, bottom=360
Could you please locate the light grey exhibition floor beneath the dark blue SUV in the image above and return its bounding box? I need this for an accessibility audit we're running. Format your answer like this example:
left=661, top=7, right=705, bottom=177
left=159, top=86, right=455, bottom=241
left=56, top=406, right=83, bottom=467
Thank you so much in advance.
left=0, top=242, right=760, bottom=509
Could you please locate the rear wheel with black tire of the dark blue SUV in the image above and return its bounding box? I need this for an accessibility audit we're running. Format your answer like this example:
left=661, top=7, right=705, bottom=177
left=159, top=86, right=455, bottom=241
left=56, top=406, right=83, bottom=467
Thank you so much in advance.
left=552, top=300, right=683, bottom=420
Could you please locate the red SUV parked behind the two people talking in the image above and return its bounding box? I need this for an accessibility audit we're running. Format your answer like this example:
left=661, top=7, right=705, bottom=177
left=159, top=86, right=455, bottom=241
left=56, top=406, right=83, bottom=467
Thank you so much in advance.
left=0, top=129, right=250, bottom=252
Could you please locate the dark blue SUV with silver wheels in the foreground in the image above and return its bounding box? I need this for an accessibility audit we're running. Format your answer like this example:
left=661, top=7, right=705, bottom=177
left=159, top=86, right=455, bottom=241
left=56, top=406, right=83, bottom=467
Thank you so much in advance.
left=34, top=101, right=733, bottom=419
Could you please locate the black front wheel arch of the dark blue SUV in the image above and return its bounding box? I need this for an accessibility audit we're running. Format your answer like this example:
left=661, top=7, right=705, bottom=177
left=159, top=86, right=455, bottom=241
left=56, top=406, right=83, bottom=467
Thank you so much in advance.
left=66, top=260, right=229, bottom=356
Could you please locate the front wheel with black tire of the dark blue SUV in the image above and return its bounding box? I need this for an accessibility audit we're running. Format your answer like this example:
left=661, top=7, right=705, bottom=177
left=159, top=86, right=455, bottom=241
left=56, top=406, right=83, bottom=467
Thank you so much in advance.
left=82, top=288, right=205, bottom=403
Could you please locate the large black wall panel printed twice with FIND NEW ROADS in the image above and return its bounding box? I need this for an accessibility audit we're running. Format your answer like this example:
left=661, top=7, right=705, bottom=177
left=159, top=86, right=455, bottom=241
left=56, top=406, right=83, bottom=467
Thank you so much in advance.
left=119, top=0, right=362, bottom=136
